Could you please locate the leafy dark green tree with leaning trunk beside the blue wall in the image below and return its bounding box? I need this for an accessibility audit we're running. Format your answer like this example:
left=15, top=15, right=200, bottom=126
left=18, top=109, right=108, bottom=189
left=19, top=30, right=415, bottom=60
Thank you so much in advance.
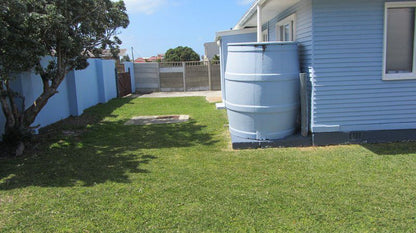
left=0, top=0, right=129, bottom=151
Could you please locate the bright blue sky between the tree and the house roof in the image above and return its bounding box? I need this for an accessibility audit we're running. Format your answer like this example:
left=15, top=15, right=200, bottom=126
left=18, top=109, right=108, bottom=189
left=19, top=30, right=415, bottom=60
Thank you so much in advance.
left=119, top=0, right=252, bottom=58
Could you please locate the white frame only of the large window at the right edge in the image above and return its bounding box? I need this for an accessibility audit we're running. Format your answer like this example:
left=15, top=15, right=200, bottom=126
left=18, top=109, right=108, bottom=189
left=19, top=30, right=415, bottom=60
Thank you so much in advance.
left=382, top=1, right=416, bottom=80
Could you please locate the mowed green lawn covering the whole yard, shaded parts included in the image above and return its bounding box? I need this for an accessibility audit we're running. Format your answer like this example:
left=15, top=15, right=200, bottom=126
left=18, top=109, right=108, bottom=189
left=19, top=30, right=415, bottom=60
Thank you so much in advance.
left=0, top=97, right=416, bottom=232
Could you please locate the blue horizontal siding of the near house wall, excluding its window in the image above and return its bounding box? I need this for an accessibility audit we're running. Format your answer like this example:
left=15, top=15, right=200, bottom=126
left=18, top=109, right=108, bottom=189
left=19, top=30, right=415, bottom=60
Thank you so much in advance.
left=311, top=0, right=416, bottom=132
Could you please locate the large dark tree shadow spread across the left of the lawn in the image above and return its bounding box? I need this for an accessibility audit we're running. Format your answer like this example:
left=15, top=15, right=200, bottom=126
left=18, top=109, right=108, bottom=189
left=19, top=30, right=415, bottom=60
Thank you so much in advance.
left=0, top=99, right=216, bottom=190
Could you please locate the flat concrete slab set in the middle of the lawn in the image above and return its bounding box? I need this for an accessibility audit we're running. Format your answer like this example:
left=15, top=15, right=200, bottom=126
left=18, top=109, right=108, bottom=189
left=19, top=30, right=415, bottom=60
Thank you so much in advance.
left=125, top=115, right=189, bottom=125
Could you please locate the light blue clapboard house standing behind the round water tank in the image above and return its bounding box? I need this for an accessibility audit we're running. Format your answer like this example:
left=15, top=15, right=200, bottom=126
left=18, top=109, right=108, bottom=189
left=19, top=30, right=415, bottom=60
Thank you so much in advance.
left=216, top=0, right=416, bottom=145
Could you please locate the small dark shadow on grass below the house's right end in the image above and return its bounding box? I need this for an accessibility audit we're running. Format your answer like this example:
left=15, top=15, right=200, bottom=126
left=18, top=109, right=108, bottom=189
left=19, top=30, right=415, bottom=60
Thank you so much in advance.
left=361, top=142, right=416, bottom=155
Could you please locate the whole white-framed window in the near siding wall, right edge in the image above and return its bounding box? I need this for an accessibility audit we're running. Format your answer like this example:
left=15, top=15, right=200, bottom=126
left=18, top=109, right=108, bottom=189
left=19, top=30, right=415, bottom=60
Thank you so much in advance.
left=383, top=1, right=416, bottom=80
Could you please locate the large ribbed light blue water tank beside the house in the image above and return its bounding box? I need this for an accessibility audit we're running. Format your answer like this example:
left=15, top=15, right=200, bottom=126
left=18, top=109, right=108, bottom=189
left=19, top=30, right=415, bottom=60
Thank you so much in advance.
left=225, top=42, right=300, bottom=140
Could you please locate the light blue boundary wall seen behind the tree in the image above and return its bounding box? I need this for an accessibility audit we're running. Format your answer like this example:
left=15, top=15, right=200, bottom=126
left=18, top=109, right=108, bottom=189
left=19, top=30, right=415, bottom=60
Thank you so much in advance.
left=0, top=59, right=117, bottom=140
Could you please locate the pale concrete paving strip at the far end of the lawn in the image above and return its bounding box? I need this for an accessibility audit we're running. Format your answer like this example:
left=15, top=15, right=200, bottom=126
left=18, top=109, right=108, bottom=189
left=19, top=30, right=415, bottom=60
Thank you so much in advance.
left=131, top=91, right=221, bottom=102
